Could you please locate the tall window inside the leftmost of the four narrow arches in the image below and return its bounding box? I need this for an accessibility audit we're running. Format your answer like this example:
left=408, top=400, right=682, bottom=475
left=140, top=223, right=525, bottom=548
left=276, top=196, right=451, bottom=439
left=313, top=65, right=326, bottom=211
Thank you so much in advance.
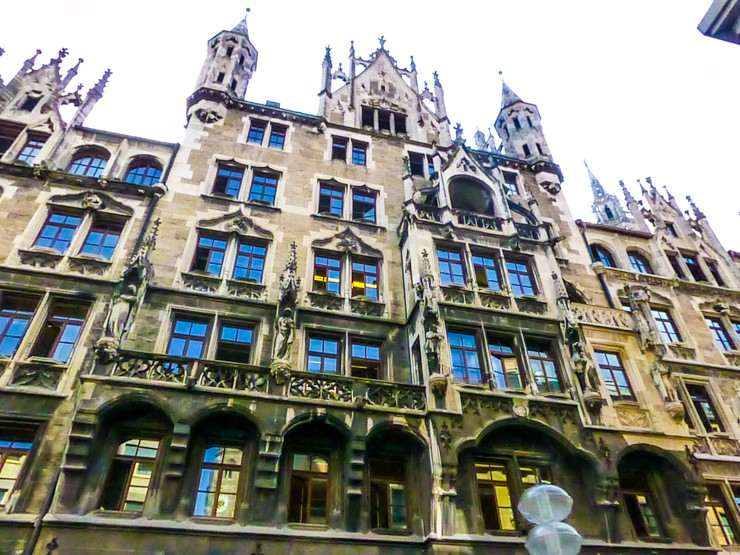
left=100, top=438, right=159, bottom=512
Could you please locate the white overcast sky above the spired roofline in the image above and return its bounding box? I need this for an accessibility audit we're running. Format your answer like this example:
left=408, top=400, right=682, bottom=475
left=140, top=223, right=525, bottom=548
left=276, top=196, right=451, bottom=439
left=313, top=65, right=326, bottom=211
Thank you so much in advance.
left=0, top=0, right=740, bottom=250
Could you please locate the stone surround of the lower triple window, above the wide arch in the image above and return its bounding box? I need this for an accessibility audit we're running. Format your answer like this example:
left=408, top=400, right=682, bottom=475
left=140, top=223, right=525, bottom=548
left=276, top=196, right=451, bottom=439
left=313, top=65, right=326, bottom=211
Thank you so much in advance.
left=443, top=323, right=570, bottom=396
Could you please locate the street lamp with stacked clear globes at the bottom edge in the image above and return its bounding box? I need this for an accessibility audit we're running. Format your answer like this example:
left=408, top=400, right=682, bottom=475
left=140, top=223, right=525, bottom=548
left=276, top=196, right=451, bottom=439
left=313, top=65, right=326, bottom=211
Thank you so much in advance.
left=519, top=484, right=583, bottom=555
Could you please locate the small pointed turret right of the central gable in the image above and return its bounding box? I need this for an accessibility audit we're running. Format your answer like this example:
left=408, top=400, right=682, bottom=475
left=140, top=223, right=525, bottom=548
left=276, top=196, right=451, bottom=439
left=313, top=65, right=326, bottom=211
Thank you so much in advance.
left=495, top=80, right=552, bottom=161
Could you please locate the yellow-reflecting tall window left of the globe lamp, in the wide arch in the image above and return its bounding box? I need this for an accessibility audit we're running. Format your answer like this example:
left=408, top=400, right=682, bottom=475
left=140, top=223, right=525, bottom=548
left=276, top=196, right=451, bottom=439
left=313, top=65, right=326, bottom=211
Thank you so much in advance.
left=475, top=463, right=516, bottom=531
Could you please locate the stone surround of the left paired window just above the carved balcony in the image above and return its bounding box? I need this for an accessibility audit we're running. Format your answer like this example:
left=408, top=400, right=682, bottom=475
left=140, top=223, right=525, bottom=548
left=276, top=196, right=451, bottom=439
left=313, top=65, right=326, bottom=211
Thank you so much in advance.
left=154, top=305, right=264, bottom=364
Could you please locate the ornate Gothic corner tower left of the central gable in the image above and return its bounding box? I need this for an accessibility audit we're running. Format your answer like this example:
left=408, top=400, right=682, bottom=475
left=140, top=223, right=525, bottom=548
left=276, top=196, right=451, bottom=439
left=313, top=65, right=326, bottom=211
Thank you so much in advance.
left=188, top=10, right=257, bottom=123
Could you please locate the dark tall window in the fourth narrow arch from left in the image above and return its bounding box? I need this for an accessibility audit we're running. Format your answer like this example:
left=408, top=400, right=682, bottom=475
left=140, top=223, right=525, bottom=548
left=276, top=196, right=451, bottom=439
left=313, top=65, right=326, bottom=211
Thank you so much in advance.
left=370, top=458, right=407, bottom=530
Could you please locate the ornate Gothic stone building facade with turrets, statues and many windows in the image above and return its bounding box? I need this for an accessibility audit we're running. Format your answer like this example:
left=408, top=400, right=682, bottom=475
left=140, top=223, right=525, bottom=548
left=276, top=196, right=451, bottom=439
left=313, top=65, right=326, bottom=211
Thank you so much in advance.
left=0, top=13, right=740, bottom=555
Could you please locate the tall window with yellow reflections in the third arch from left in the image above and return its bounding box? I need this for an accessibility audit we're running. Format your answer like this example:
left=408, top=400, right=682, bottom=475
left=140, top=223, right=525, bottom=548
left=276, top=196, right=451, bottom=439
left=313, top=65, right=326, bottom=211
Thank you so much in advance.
left=288, top=453, right=329, bottom=524
